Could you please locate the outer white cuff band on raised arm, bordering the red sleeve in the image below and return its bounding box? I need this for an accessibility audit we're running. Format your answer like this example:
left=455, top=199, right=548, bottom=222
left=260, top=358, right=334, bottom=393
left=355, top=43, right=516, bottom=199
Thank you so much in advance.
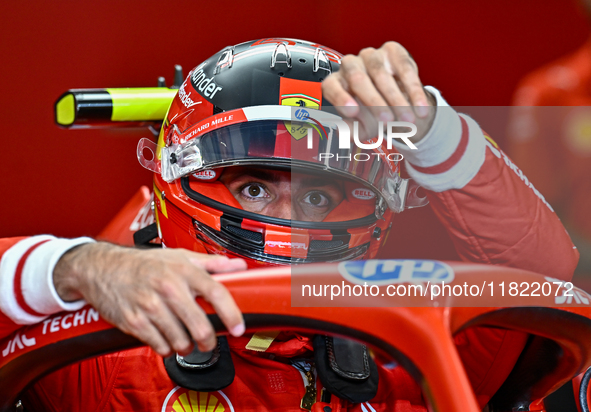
left=407, top=115, right=486, bottom=192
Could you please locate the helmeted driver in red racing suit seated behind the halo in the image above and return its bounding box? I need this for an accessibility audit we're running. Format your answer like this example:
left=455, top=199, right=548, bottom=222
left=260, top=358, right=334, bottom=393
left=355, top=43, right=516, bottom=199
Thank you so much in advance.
left=0, top=38, right=578, bottom=411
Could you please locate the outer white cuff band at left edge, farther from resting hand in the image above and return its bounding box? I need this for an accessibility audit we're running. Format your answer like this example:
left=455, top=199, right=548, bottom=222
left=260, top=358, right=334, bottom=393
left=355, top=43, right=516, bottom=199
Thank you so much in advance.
left=0, top=235, right=55, bottom=325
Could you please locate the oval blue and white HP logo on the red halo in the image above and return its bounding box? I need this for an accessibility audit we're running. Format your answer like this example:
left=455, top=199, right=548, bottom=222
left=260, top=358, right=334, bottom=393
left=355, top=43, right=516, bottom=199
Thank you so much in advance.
left=338, top=259, right=454, bottom=285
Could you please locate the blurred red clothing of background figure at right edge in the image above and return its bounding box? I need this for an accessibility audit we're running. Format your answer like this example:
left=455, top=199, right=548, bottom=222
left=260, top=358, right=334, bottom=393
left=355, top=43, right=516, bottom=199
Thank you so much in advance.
left=507, top=38, right=591, bottom=276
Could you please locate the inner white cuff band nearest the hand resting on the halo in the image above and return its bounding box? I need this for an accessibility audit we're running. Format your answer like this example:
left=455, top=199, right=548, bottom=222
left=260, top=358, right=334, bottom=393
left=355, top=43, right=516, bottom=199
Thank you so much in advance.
left=22, top=237, right=93, bottom=315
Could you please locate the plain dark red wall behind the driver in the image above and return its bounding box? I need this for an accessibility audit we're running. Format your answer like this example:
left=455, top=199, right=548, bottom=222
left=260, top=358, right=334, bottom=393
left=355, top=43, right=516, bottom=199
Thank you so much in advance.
left=0, top=0, right=589, bottom=258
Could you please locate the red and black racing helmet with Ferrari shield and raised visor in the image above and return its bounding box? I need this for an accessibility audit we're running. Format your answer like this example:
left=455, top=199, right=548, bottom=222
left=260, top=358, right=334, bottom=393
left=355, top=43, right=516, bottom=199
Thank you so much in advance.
left=138, top=38, right=424, bottom=267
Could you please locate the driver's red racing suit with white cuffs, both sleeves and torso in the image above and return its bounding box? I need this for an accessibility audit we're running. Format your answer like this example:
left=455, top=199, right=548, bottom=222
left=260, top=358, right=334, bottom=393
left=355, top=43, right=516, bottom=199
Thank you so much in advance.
left=0, top=88, right=578, bottom=412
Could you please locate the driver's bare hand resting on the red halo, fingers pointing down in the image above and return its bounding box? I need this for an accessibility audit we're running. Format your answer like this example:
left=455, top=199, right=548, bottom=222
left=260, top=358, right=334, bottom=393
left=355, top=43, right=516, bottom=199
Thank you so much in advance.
left=54, top=242, right=246, bottom=356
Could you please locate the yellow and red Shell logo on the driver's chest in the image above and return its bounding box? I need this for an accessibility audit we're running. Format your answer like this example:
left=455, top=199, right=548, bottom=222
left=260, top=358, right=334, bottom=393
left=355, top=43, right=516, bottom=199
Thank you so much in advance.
left=162, top=386, right=234, bottom=412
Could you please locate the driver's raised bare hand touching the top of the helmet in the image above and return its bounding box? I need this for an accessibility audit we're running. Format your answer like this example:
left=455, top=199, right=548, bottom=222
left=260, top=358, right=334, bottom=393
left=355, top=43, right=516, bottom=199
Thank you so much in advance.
left=322, top=42, right=435, bottom=142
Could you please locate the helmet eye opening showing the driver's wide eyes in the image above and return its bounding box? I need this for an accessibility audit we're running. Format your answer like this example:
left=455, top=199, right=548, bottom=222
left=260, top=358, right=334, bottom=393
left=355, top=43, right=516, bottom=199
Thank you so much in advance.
left=187, top=165, right=378, bottom=225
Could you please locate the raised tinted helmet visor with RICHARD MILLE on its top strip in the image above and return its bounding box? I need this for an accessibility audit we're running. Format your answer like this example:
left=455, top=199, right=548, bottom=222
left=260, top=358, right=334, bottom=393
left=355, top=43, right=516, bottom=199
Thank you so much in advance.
left=138, top=106, right=420, bottom=216
